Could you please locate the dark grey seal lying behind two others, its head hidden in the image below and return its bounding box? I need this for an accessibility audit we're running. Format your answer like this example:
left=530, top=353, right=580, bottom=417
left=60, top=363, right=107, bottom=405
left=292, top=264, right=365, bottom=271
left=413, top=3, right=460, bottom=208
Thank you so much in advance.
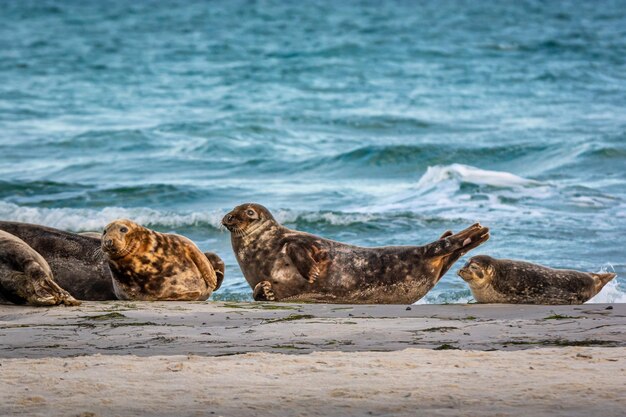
left=0, top=221, right=115, bottom=301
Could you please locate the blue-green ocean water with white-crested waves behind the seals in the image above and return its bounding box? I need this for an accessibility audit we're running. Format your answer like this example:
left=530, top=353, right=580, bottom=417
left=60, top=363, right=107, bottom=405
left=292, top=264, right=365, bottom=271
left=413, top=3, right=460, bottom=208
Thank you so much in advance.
left=0, top=0, right=626, bottom=303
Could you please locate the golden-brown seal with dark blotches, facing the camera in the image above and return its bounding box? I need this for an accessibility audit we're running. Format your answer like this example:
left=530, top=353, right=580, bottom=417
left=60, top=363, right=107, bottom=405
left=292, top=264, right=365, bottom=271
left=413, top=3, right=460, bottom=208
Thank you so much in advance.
left=102, top=219, right=224, bottom=301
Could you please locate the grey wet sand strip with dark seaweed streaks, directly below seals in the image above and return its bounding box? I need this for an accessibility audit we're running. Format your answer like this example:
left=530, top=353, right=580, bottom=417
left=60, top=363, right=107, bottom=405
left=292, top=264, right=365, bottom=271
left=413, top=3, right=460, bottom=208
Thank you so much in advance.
left=0, top=301, right=626, bottom=358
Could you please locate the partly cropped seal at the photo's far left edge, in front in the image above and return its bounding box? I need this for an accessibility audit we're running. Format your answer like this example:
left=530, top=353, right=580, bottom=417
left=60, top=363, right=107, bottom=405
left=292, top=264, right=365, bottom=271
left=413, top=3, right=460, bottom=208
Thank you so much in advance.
left=0, top=230, right=80, bottom=306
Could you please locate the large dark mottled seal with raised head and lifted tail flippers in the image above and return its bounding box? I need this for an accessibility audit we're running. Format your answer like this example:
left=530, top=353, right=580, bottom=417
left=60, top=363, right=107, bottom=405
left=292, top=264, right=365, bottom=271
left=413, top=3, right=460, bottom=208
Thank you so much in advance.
left=222, top=203, right=489, bottom=304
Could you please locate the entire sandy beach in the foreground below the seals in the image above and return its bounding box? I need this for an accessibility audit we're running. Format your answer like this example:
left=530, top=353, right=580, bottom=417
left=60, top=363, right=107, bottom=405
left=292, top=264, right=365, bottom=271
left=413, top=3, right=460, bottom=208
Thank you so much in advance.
left=0, top=302, right=626, bottom=416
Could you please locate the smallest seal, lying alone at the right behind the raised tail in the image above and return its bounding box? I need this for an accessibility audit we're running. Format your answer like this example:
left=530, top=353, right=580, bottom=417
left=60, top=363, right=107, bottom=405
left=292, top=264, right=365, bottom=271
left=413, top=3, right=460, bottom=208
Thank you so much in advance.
left=458, top=255, right=616, bottom=304
